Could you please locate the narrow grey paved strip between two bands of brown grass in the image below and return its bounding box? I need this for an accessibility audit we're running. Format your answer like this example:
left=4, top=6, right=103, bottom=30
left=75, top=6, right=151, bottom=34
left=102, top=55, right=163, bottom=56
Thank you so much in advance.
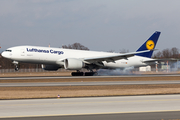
left=0, top=80, right=180, bottom=87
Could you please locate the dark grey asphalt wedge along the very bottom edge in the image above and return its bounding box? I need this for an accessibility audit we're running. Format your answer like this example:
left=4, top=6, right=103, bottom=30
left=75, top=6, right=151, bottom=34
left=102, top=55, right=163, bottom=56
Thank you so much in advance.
left=2, top=111, right=180, bottom=120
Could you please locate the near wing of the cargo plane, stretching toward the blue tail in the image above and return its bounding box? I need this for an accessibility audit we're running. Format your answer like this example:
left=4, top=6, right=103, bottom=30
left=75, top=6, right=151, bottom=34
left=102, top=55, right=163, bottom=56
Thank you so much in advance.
left=83, top=50, right=151, bottom=64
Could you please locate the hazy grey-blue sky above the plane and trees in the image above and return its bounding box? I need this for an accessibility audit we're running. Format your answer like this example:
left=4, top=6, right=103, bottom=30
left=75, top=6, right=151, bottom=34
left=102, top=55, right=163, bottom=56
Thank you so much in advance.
left=0, top=0, right=180, bottom=52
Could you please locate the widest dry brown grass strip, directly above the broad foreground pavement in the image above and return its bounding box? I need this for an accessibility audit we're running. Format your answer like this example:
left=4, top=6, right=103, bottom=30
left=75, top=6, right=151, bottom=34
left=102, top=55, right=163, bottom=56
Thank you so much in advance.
left=0, top=84, right=180, bottom=99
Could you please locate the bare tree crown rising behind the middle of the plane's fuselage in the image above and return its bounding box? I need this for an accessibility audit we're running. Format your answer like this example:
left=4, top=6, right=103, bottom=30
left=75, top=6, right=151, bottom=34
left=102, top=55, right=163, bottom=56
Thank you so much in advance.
left=62, top=43, right=89, bottom=50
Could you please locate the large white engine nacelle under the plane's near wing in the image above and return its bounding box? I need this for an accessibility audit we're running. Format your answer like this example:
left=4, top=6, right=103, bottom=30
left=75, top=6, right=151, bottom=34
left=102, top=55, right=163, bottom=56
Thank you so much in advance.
left=64, top=58, right=85, bottom=70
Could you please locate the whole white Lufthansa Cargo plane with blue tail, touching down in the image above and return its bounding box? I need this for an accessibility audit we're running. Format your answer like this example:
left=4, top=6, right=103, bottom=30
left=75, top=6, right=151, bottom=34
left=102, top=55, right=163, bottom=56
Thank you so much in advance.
left=2, top=31, right=160, bottom=76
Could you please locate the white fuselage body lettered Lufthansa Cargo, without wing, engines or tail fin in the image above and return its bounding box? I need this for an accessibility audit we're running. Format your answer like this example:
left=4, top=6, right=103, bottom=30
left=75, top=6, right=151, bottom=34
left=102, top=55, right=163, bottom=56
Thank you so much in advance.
left=2, top=46, right=152, bottom=68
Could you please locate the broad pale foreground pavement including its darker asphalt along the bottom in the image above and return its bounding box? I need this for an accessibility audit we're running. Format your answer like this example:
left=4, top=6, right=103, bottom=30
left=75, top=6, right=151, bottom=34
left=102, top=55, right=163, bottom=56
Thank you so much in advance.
left=0, top=95, right=180, bottom=120
